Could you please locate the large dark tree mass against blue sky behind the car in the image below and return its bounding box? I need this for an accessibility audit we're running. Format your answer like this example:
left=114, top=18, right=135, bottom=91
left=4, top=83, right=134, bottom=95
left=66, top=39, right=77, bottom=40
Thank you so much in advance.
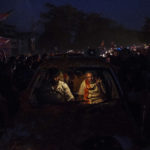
left=39, top=3, right=139, bottom=50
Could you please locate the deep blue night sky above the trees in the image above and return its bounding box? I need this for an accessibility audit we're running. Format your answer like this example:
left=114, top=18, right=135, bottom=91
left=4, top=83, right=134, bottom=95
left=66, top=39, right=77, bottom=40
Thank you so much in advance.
left=0, top=0, right=150, bottom=31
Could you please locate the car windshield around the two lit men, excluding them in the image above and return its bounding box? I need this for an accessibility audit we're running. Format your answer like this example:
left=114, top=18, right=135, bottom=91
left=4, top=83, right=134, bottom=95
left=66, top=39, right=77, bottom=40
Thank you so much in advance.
left=30, top=67, right=120, bottom=103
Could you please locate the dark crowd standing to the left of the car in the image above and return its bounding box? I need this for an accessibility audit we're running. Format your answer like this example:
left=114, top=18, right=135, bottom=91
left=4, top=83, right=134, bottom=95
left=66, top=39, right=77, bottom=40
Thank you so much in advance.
left=0, top=55, right=47, bottom=126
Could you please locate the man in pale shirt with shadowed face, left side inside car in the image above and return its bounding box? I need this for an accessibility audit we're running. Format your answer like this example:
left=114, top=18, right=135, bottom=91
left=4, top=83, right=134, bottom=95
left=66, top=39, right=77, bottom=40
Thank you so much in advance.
left=36, top=69, right=74, bottom=105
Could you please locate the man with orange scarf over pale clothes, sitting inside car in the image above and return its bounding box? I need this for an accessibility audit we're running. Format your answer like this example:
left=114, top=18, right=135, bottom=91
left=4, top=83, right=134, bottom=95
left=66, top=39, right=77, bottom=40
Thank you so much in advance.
left=78, top=72, right=105, bottom=104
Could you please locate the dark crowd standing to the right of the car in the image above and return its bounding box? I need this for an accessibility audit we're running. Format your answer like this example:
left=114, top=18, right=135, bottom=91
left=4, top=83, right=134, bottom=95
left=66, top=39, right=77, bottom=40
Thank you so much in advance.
left=106, top=48, right=150, bottom=135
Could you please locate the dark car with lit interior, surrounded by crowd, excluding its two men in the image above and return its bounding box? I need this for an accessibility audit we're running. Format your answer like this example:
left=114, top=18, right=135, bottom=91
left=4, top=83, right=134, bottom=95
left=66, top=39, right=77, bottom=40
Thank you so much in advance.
left=1, top=57, right=140, bottom=150
